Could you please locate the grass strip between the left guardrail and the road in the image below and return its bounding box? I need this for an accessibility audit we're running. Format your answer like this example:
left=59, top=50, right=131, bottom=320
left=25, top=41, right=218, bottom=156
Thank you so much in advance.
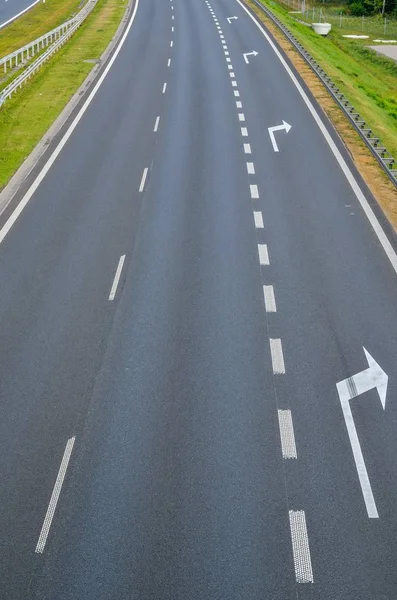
left=0, top=0, right=127, bottom=190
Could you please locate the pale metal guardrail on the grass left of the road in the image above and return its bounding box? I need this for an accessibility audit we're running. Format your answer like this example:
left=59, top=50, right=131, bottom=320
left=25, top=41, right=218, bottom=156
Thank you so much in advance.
left=0, top=0, right=98, bottom=107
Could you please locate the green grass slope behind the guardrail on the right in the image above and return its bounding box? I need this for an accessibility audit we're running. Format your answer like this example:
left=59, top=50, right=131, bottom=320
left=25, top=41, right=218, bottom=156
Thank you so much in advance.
left=261, top=0, right=397, bottom=157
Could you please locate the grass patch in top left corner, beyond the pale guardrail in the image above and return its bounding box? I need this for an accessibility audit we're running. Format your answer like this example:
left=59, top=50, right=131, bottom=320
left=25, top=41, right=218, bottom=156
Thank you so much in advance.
left=0, top=0, right=85, bottom=57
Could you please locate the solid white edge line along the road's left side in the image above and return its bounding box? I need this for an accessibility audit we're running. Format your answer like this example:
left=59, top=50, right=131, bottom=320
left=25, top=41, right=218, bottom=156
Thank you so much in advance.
left=0, top=0, right=139, bottom=244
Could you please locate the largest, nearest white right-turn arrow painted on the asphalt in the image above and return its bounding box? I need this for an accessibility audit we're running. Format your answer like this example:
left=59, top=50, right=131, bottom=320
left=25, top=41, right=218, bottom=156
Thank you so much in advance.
left=336, top=348, right=389, bottom=519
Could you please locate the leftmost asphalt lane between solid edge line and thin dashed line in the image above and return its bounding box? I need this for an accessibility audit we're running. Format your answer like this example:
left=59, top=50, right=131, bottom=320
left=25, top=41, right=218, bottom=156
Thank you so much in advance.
left=0, top=2, right=169, bottom=600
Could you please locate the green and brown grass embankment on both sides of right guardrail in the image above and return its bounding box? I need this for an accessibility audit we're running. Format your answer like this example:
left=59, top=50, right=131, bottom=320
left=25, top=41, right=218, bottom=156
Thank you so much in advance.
left=246, top=0, right=397, bottom=230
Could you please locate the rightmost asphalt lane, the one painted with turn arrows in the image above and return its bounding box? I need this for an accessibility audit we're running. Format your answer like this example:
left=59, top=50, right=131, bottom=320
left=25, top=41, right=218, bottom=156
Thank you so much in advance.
left=212, top=0, right=397, bottom=600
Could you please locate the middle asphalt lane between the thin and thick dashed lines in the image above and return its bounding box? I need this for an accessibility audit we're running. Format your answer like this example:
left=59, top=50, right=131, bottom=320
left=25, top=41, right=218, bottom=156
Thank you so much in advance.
left=30, top=2, right=295, bottom=600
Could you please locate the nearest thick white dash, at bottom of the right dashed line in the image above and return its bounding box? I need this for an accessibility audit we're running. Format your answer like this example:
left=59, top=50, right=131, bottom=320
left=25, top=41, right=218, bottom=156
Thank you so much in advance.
left=289, top=510, right=313, bottom=583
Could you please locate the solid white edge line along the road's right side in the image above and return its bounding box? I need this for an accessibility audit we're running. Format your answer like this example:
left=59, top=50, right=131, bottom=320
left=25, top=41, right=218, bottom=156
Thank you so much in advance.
left=236, top=0, right=397, bottom=273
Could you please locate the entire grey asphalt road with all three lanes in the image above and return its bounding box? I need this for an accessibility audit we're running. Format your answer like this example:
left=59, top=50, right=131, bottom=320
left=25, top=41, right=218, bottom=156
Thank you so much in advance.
left=0, top=0, right=397, bottom=600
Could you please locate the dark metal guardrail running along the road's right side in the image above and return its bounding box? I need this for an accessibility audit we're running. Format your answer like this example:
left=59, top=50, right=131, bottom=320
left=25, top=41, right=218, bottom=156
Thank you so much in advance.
left=252, top=0, right=397, bottom=187
